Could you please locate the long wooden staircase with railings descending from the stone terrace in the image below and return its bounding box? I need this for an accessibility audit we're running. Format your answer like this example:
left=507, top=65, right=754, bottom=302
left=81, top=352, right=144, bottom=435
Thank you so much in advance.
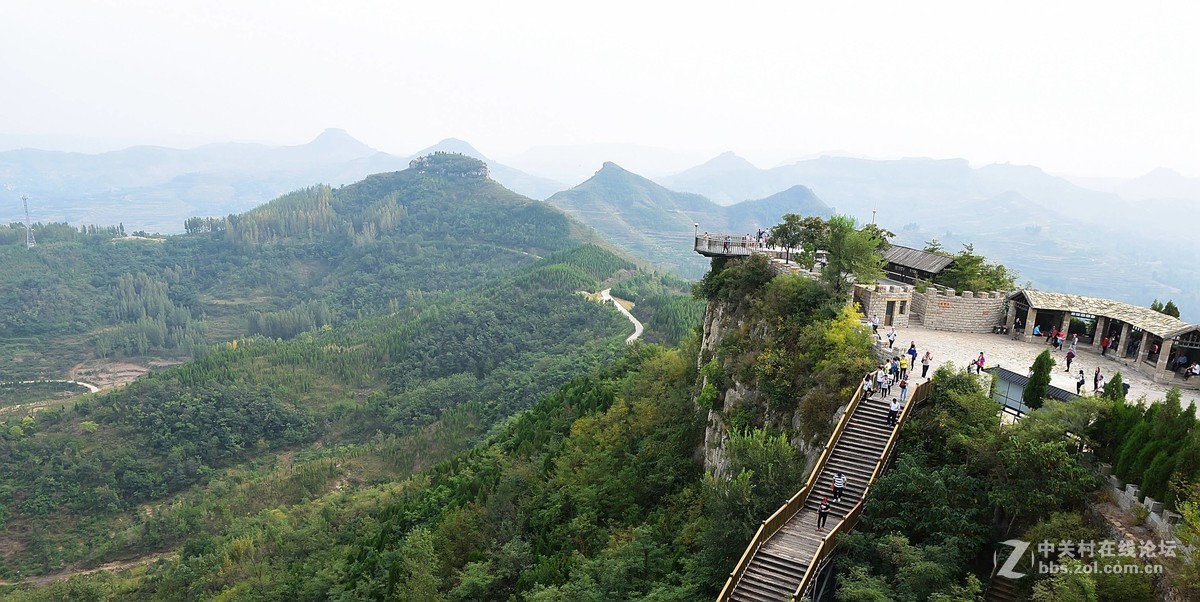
left=718, top=383, right=931, bottom=602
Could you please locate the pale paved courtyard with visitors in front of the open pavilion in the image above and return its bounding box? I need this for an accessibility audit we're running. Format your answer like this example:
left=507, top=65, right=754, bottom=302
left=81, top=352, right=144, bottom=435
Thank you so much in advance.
left=880, top=326, right=1200, bottom=407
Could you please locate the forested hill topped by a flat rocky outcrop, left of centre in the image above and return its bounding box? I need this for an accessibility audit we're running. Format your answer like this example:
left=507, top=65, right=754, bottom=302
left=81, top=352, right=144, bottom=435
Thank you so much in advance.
left=0, top=155, right=609, bottom=380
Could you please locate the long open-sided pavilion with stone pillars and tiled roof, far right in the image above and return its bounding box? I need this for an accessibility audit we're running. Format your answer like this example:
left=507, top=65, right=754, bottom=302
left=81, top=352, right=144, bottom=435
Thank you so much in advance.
left=1008, top=289, right=1200, bottom=383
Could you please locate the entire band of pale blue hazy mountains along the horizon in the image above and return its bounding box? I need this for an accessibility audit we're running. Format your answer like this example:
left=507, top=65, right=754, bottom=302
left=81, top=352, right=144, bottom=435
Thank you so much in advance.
left=0, top=130, right=1200, bottom=318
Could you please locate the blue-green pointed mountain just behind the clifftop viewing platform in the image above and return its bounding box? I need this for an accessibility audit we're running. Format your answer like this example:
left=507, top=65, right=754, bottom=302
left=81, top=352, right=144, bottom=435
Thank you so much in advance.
left=546, top=162, right=832, bottom=278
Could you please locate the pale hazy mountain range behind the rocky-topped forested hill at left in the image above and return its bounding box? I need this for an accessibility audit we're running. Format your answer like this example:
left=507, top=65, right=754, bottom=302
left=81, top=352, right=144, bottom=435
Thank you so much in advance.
left=0, top=130, right=566, bottom=233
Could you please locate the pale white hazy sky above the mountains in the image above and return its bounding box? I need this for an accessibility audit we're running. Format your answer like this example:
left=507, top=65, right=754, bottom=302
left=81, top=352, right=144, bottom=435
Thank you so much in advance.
left=0, top=0, right=1200, bottom=176
